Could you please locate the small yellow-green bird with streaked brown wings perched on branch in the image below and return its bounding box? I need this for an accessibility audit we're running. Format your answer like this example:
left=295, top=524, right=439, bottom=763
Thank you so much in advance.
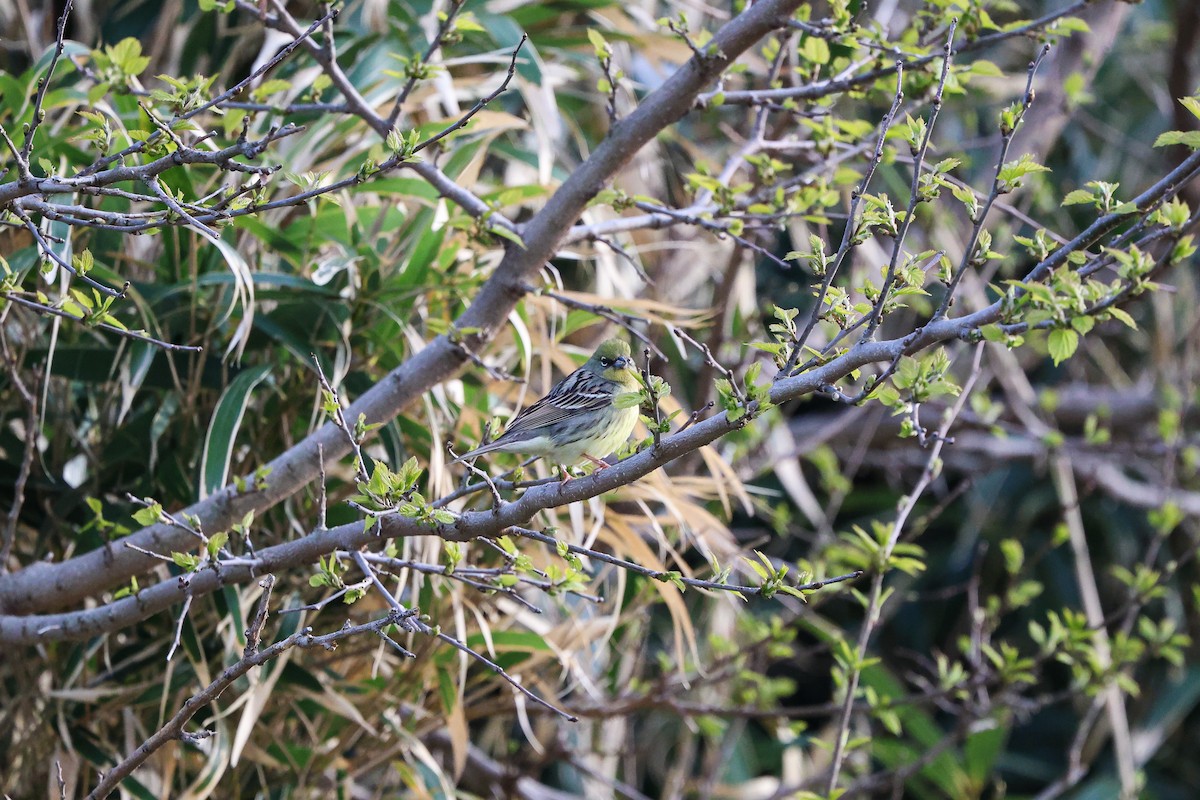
left=450, top=338, right=640, bottom=483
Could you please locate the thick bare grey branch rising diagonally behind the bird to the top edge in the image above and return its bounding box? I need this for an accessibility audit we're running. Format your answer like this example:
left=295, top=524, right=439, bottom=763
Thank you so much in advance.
left=0, top=0, right=800, bottom=622
